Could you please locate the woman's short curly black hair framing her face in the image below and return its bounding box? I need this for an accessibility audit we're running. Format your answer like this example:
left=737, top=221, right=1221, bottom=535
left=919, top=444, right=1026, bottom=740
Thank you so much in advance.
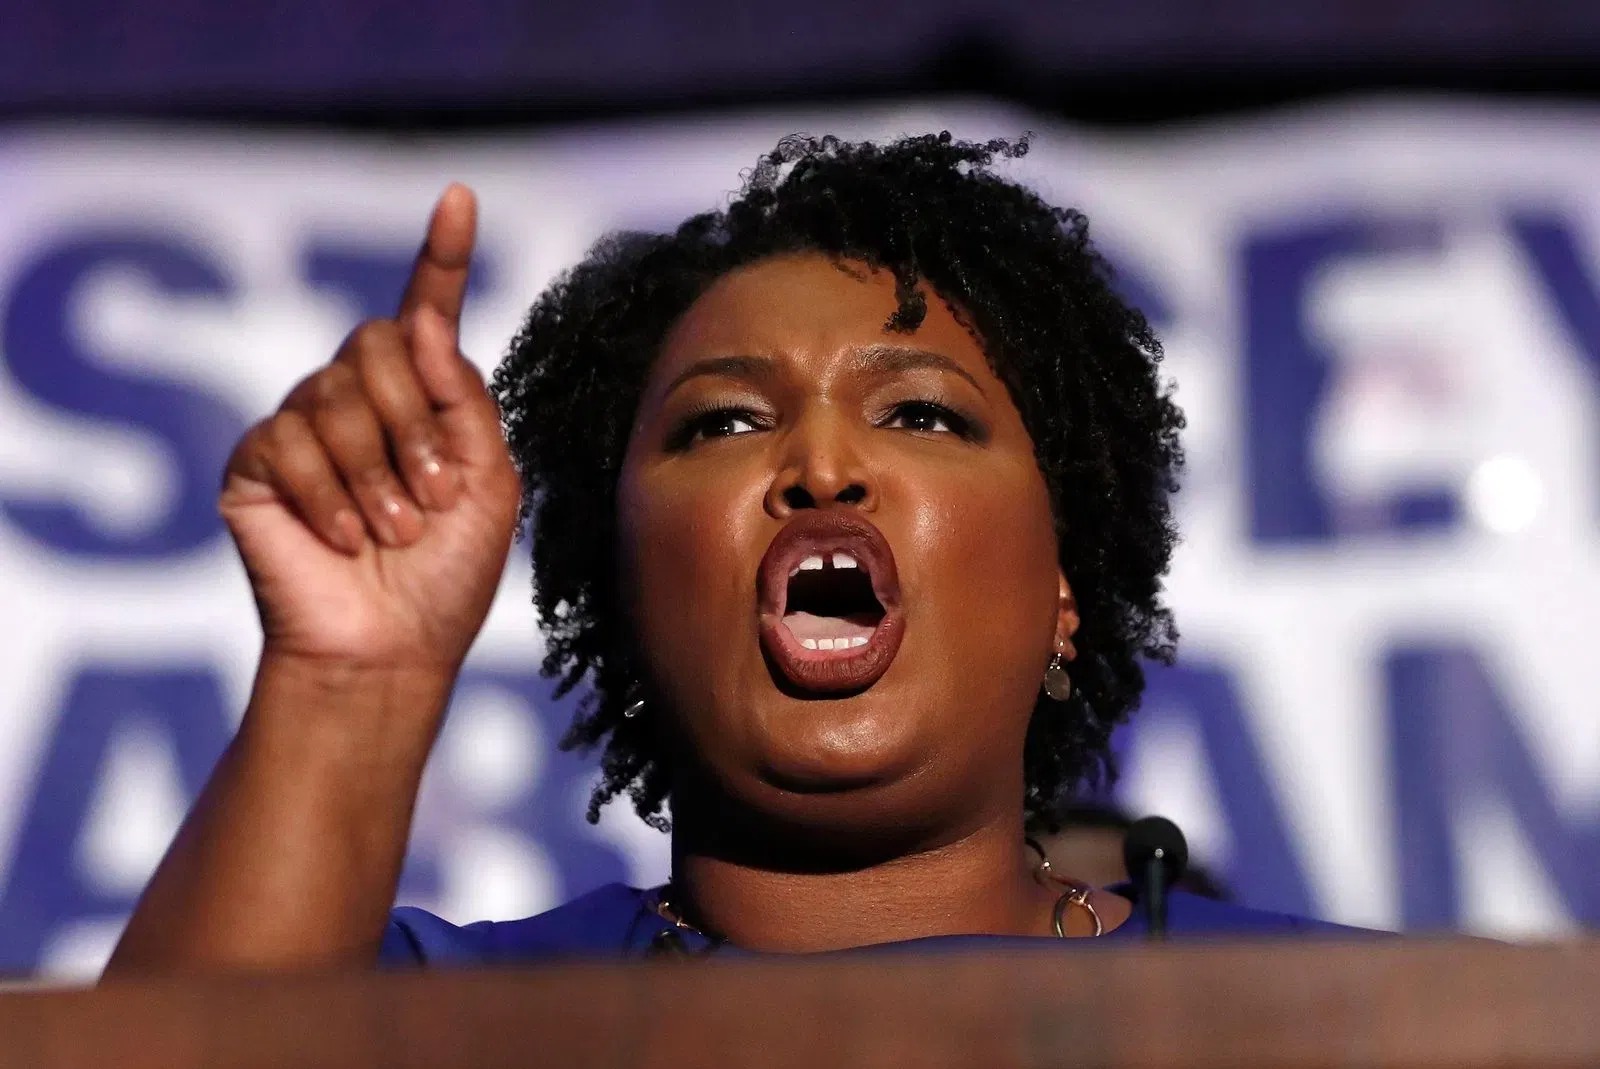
left=493, top=133, right=1182, bottom=831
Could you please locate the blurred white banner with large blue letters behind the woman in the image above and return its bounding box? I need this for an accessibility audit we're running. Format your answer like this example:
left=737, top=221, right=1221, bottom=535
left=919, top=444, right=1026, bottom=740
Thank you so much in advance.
left=0, top=104, right=1600, bottom=975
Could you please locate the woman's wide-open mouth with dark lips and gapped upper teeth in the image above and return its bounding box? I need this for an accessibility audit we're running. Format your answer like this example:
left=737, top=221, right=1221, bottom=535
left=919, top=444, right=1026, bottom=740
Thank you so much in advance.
left=757, top=512, right=904, bottom=693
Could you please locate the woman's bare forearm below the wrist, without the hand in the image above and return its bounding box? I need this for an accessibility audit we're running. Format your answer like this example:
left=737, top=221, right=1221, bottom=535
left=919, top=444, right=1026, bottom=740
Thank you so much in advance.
left=106, top=658, right=451, bottom=976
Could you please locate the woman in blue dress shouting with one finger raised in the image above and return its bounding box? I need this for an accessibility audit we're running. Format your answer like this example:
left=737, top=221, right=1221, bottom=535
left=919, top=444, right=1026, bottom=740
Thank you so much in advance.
left=110, top=129, right=1344, bottom=973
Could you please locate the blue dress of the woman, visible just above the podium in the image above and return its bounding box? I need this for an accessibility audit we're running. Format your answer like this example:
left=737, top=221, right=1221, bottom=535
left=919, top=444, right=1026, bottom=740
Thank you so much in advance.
left=379, top=883, right=1363, bottom=967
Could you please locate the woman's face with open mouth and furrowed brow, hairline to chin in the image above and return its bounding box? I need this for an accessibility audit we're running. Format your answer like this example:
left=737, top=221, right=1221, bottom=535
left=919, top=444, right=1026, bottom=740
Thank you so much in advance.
left=618, top=256, right=1077, bottom=840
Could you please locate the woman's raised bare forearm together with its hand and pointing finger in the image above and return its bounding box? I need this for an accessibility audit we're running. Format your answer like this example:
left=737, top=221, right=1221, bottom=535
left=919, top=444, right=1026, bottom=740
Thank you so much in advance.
left=107, top=186, right=520, bottom=976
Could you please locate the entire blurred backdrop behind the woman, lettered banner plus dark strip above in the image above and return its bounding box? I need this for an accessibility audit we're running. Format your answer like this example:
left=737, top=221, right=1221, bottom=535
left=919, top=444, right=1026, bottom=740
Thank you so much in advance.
left=0, top=0, right=1600, bottom=978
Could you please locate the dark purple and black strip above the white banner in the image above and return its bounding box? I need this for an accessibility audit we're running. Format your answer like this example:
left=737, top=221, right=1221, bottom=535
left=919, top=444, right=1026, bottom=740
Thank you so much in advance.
left=9, top=0, right=1600, bottom=126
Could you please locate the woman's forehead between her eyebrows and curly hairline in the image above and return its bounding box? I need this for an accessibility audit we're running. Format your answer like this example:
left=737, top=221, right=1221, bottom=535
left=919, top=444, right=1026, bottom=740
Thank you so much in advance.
left=656, top=254, right=992, bottom=376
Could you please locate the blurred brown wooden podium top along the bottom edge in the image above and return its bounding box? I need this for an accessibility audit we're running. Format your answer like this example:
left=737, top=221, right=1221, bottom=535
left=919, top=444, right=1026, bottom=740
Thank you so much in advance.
left=0, top=939, right=1600, bottom=1069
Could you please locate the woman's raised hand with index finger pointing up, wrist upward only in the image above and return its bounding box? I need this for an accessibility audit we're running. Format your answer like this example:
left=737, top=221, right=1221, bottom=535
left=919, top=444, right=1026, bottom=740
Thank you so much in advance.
left=219, top=184, right=518, bottom=672
